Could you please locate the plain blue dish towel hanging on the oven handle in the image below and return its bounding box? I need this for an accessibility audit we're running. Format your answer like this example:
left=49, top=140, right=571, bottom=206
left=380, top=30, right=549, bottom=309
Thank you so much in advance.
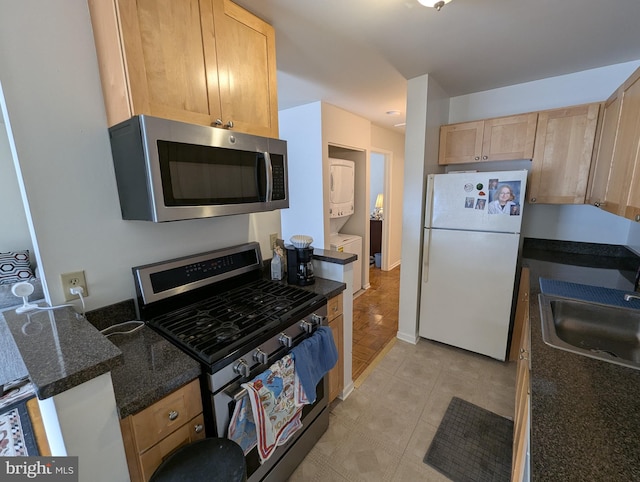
left=291, top=326, right=338, bottom=403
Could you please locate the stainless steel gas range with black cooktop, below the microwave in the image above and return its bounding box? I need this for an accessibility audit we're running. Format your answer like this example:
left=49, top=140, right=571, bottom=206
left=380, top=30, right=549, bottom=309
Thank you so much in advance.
left=133, top=243, right=329, bottom=481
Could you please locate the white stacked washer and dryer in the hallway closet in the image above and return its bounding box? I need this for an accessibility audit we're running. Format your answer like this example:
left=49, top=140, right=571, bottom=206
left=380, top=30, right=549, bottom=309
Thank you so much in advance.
left=329, top=159, right=362, bottom=293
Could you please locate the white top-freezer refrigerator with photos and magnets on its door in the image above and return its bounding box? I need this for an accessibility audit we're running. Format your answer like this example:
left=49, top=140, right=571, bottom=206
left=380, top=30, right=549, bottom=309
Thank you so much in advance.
left=419, top=170, right=527, bottom=360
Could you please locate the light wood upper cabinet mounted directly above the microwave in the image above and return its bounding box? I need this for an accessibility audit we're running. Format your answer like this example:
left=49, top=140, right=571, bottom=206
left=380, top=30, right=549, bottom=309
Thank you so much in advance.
left=89, top=0, right=278, bottom=137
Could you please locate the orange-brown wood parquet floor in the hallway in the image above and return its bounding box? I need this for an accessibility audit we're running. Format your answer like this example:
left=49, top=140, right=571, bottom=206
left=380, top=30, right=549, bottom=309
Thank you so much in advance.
left=353, top=266, right=400, bottom=380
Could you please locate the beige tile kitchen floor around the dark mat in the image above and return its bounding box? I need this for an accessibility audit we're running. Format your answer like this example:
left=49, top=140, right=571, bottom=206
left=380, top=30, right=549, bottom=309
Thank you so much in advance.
left=289, top=266, right=516, bottom=482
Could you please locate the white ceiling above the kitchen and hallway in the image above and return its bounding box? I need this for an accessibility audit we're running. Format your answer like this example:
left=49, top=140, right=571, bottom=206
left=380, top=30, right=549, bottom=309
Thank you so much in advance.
left=234, top=0, right=640, bottom=131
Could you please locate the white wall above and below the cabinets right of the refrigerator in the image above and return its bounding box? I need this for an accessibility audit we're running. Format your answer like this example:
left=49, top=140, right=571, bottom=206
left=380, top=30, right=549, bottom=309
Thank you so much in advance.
left=449, top=60, right=640, bottom=245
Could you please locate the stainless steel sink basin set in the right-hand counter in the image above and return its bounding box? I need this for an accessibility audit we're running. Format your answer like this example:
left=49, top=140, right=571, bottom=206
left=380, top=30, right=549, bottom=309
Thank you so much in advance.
left=539, top=293, right=640, bottom=370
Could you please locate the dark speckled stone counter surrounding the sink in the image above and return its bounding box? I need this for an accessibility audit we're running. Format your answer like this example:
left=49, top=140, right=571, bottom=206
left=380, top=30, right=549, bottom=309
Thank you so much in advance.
left=523, top=240, right=640, bottom=482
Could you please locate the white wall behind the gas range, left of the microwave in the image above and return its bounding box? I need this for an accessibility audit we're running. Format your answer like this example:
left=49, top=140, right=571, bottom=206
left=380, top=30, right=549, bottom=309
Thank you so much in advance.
left=0, top=0, right=280, bottom=309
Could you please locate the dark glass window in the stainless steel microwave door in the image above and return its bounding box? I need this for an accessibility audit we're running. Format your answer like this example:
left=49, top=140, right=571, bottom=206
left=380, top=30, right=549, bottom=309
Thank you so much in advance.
left=158, top=140, right=266, bottom=206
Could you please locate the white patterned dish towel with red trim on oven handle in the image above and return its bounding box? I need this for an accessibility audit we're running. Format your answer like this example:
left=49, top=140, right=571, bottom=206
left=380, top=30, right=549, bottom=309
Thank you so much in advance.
left=228, top=354, right=302, bottom=463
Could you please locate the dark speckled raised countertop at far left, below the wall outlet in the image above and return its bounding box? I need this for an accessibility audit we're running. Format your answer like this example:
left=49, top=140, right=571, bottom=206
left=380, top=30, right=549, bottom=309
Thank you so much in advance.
left=0, top=308, right=122, bottom=399
